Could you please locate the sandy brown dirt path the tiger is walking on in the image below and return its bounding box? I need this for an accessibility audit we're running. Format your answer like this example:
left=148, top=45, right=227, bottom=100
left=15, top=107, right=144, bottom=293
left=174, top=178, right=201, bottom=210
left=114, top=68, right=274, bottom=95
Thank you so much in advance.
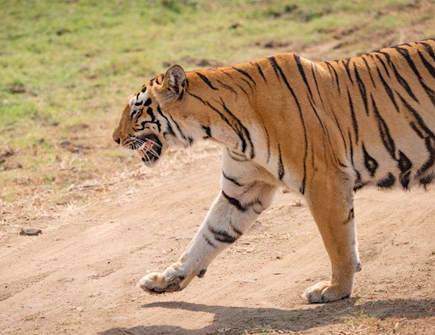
left=0, top=148, right=435, bottom=335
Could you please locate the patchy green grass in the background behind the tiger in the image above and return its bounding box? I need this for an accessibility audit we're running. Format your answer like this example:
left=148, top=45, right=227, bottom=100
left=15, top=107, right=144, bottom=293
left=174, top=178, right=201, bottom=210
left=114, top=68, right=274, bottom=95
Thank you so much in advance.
left=0, top=0, right=434, bottom=199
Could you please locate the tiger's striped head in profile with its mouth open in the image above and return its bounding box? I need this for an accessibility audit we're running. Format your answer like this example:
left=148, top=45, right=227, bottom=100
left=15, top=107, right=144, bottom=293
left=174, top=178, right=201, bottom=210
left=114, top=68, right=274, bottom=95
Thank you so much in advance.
left=112, top=65, right=191, bottom=166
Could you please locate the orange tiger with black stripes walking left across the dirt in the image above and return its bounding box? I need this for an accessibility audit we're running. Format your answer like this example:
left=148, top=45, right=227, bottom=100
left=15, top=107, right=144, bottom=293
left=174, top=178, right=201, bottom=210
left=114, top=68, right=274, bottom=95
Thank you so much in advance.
left=113, top=39, right=435, bottom=303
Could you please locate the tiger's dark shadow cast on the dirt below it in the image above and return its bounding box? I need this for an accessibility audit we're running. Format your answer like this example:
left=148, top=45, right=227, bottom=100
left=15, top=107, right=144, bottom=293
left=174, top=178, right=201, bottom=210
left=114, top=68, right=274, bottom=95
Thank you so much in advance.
left=98, top=298, right=435, bottom=335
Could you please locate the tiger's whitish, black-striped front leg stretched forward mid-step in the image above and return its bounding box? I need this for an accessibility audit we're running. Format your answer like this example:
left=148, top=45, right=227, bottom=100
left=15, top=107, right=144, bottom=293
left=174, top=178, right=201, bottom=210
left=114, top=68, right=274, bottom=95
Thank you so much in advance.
left=139, top=168, right=275, bottom=293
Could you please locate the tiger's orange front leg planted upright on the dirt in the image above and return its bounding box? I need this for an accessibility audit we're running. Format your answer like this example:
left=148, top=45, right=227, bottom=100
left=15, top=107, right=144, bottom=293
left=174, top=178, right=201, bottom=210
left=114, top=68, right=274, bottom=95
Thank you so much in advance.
left=303, top=173, right=361, bottom=303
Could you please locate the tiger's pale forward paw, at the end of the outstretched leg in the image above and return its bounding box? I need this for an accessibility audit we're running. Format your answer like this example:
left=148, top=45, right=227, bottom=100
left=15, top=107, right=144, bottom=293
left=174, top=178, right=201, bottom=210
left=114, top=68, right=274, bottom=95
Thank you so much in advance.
left=138, top=265, right=185, bottom=293
